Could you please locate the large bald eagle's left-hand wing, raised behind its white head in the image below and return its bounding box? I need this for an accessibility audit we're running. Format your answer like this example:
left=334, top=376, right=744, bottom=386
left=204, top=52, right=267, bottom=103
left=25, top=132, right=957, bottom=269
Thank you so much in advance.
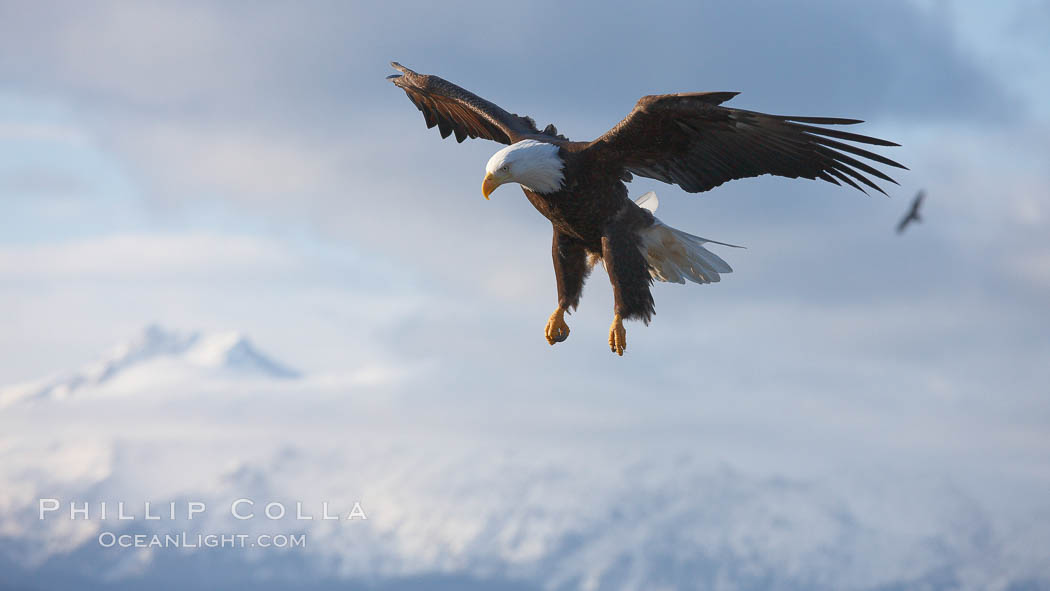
left=386, top=62, right=565, bottom=144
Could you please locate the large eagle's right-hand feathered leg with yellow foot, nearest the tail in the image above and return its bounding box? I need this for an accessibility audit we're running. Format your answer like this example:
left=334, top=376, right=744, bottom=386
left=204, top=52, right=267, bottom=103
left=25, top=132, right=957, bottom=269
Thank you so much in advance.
left=602, top=218, right=655, bottom=356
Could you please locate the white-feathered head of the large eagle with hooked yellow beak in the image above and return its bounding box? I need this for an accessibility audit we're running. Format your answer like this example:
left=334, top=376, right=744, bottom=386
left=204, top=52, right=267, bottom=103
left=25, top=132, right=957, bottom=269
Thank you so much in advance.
left=481, top=140, right=565, bottom=199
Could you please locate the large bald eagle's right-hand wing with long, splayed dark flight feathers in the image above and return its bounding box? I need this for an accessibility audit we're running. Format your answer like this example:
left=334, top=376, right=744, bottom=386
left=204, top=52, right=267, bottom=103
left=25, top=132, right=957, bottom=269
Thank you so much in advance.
left=585, top=92, right=905, bottom=194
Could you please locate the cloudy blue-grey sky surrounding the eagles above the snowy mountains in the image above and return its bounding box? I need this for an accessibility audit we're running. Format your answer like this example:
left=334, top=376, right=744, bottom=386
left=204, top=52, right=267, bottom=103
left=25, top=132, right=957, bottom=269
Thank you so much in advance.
left=0, top=0, right=1050, bottom=587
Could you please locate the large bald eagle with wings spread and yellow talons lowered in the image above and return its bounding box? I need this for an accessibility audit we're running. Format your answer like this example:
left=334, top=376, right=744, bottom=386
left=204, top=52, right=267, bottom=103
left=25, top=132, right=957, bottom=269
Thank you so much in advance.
left=387, top=62, right=905, bottom=356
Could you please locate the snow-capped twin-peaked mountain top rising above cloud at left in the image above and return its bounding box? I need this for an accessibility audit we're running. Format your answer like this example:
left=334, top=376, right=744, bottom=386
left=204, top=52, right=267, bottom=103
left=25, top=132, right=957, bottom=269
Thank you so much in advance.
left=0, top=324, right=300, bottom=408
